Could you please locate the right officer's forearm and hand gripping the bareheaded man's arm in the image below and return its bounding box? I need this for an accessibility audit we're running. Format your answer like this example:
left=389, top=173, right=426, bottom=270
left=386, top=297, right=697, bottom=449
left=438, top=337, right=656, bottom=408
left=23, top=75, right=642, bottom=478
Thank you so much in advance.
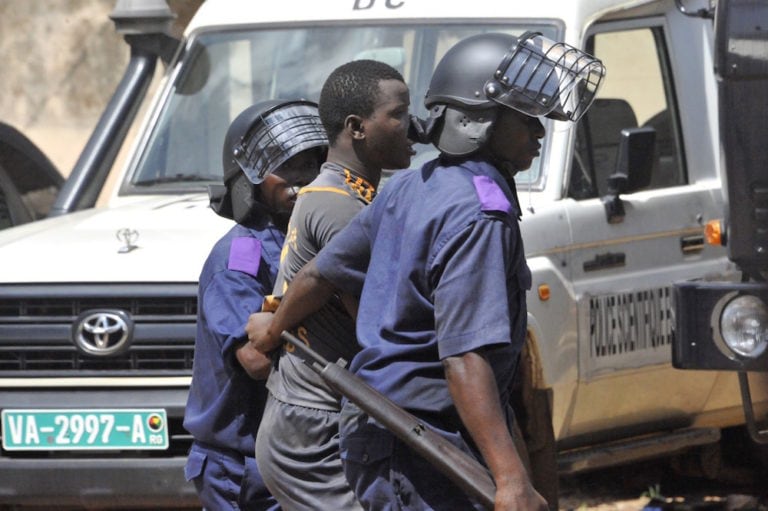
left=245, top=259, right=336, bottom=354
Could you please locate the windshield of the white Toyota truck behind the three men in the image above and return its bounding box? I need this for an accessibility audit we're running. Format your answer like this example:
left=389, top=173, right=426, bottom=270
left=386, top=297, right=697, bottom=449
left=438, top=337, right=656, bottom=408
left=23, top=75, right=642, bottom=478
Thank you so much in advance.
left=127, top=24, right=557, bottom=194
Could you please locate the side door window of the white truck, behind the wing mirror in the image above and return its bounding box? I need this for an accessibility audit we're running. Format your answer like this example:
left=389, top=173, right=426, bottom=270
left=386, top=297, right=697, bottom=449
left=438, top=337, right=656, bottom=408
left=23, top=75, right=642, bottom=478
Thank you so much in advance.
left=568, top=27, right=686, bottom=199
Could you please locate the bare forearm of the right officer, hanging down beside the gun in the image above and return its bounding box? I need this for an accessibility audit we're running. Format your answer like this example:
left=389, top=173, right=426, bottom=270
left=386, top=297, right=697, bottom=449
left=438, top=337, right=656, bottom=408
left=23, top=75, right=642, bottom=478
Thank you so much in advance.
left=443, top=351, right=547, bottom=511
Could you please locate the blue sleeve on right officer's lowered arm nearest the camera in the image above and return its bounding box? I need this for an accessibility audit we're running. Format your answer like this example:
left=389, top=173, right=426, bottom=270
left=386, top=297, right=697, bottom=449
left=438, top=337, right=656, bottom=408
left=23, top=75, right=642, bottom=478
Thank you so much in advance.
left=430, top=217, right=527, bottom=359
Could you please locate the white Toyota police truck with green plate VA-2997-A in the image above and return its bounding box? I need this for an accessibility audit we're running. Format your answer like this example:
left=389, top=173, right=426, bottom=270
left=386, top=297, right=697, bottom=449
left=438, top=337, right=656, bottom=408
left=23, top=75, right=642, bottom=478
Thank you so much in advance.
left=0, top=0, right=768, bottom=508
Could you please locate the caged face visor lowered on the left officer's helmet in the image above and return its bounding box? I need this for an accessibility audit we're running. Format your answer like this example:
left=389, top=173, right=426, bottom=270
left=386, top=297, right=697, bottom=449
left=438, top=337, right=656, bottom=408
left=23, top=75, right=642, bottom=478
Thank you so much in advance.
left=232, top=102, right=328, bottom=184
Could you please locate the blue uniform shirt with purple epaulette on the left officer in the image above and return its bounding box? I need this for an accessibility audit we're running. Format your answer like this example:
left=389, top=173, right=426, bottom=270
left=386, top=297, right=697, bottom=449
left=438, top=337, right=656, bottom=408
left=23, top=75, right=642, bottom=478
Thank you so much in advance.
left=184, top=225, right=284, bottom=457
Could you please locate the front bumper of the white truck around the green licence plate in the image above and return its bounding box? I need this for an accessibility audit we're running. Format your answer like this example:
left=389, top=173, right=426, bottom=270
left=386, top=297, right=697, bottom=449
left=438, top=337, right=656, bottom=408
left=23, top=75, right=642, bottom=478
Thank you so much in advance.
left=0, top=388, right=200, bottom=510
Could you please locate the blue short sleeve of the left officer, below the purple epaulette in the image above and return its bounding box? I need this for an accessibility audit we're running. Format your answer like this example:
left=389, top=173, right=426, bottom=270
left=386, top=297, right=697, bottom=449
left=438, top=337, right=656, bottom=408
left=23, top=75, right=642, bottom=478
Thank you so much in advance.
left=199, top=269, right=271, bottom=368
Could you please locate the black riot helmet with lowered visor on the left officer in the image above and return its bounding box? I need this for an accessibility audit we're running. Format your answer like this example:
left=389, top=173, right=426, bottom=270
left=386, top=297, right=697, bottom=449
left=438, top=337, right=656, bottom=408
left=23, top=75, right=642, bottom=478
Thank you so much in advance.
left=209, top=100, right=328, bottom=224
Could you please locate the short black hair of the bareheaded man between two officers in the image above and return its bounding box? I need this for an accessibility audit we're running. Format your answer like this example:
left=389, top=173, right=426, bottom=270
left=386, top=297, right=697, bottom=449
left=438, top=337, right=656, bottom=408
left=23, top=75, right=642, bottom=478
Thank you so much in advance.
left=319, top=59, right=405, bottom=144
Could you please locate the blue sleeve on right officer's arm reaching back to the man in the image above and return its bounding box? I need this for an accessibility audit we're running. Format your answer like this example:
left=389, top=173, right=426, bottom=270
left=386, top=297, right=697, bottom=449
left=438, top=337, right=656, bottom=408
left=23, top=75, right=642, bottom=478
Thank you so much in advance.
left=315, top=207, right=374, bottom=296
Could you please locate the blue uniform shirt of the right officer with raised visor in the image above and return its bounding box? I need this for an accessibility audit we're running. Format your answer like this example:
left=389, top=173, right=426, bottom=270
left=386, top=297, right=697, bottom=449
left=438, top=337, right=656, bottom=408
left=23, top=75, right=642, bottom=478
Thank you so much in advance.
left=316, top=159, right=531, bottom=430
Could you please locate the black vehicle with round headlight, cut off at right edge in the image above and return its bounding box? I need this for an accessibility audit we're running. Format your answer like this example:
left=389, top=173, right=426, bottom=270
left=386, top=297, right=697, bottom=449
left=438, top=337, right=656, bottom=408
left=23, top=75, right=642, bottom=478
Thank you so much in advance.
left=672, top=0, right=768, bottom=444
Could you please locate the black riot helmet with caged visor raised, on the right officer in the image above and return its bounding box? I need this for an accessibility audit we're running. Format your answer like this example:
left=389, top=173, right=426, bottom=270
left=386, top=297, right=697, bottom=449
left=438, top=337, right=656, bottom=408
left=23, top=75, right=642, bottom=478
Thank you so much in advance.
left=424, top=32, right=605, bottom=156
